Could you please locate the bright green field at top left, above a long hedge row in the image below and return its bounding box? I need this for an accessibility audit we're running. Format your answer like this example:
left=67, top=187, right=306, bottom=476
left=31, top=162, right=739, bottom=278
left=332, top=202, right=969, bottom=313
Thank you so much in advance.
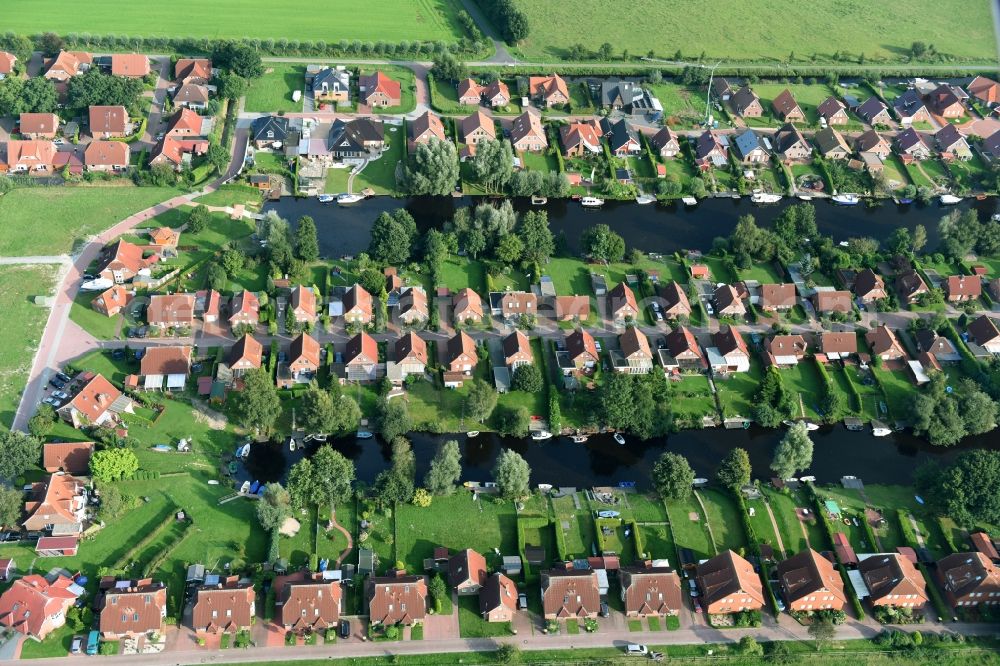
left=4, top=0, right=462, bottom=43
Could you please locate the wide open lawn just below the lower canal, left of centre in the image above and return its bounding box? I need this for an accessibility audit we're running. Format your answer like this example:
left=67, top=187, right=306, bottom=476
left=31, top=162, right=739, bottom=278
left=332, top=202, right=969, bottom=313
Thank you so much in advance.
left=385, top=491, right=517, bottom=572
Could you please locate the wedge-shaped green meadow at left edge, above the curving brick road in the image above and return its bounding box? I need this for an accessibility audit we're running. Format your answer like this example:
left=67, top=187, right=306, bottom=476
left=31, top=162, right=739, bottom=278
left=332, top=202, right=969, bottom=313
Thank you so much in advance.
left=0, top=186, right=180, bottom=257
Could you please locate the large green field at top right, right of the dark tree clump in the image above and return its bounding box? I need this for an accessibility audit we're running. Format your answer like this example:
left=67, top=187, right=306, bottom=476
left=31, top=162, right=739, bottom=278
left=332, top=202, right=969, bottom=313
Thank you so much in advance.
left=515, top=0, right=996, bottom=62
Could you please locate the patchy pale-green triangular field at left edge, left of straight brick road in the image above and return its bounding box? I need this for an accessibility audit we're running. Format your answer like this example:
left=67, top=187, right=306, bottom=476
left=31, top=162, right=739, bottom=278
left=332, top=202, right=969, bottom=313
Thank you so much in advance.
left=0, top=266, right=56, bottom=428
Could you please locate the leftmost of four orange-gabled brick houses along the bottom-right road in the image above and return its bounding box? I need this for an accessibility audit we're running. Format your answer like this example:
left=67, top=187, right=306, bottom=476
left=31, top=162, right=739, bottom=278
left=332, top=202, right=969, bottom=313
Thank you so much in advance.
left=695, top=550, right=764, bottom=615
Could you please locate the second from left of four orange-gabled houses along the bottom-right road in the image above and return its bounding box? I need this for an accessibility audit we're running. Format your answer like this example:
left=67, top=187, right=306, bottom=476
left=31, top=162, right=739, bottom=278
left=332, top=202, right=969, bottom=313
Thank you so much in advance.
left=775, top=548, right=847, bottom=612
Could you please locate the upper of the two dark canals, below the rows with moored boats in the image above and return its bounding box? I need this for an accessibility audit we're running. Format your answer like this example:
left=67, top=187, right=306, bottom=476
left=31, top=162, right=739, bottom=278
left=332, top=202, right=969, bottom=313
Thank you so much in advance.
left=265, top=197, right=997, bottom=257
